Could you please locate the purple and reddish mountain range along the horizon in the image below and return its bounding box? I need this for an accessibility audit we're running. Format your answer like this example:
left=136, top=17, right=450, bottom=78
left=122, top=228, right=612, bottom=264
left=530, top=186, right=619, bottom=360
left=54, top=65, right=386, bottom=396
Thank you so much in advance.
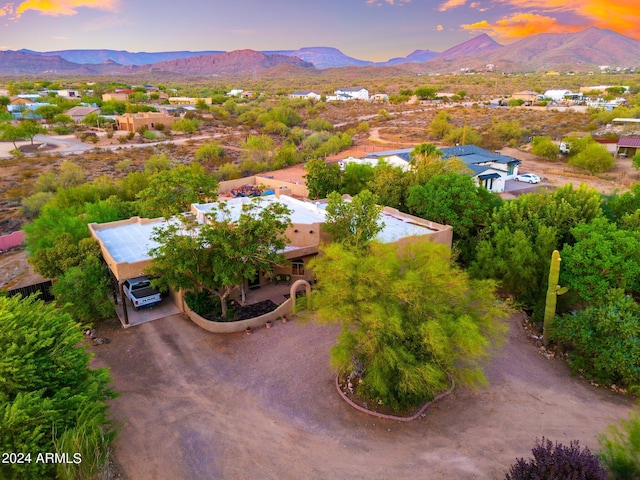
left=0, top=27, right=640, bottom=76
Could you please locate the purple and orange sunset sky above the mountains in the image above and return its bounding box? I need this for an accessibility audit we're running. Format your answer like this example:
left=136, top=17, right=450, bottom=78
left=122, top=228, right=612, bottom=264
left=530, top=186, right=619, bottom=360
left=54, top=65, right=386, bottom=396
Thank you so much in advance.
left=0, top=0, right=640, bottom=61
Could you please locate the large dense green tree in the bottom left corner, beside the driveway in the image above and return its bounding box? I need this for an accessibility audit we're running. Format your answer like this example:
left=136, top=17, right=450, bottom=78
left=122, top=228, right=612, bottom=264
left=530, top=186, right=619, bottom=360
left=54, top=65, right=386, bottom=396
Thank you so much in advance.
left=0, top=297, right=115, bottom=479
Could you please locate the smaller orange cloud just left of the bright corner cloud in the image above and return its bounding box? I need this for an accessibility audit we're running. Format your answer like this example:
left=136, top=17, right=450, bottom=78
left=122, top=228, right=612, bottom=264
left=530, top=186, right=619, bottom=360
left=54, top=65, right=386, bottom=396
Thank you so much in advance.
left=462, top=13, right=584, bottom=41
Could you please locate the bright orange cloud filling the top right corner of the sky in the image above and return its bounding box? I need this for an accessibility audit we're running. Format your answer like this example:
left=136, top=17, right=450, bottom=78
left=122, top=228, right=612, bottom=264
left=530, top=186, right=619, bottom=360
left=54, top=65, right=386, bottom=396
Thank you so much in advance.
left=496, top=0, right=640, bottom=40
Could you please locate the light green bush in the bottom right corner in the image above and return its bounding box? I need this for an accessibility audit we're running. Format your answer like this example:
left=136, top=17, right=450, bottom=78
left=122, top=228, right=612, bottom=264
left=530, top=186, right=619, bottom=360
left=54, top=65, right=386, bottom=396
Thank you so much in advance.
left=599, top=411, right=640, bottom=480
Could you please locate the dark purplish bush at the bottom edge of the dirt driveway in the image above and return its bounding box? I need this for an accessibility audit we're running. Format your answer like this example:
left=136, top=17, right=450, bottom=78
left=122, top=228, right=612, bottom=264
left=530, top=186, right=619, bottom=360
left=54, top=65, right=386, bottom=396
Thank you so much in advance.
left=505, top=437, right=607, bottom=480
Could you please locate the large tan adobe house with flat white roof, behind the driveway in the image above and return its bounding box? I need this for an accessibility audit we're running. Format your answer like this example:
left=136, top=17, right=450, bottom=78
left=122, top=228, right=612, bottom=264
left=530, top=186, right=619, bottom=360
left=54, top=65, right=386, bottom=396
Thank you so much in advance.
left=88, top=177, right=453, bottom=324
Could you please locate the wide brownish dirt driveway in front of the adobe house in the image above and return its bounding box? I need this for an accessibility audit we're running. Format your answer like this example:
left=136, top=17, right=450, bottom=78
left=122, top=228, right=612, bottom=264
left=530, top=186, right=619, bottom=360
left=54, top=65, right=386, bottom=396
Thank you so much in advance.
left=91, top=316, right=632, bottom=480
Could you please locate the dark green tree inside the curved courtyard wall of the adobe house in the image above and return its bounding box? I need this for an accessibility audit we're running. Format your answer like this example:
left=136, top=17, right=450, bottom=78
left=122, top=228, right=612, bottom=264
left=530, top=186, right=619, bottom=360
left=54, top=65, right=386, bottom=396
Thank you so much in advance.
left=148, top=199, right=290, bottom=316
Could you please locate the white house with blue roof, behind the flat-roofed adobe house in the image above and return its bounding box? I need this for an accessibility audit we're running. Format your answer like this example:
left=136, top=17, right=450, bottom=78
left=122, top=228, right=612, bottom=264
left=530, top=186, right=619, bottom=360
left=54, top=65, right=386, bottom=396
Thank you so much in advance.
left=360, top=145, right=521, bottom=193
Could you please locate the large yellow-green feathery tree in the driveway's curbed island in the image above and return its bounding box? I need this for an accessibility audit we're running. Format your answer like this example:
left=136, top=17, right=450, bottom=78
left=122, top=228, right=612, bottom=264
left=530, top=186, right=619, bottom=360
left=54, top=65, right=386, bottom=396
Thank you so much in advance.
left=309, top=241, right=504, bottom=411
